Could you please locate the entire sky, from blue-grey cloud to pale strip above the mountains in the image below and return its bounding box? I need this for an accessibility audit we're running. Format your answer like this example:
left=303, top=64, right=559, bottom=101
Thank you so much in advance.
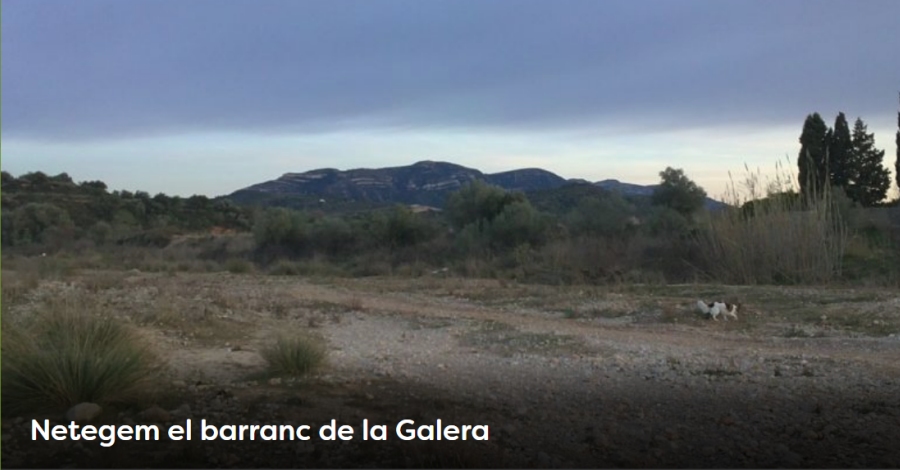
left=0, top=0, right=900, bottom=197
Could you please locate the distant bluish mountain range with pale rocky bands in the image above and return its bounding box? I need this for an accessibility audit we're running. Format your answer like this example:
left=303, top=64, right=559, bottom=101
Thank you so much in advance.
left=226, top=160, right=722, bottom=208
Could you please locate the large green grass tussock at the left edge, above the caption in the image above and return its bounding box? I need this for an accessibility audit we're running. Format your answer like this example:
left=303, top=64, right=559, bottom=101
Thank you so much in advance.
left=2, top=304, right=161, bottom=413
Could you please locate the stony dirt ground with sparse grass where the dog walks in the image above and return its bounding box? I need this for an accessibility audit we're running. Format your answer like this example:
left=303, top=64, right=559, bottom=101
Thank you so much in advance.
left=2, top=271, right=900, bottom=468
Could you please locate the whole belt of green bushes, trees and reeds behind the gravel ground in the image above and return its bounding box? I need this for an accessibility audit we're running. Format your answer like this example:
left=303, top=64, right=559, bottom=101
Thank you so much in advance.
left=2, top=151, right=900, bottom=284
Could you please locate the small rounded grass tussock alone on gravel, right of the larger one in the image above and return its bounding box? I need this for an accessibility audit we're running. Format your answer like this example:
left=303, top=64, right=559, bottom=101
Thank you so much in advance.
left=261, top=333, right=325, bottom=377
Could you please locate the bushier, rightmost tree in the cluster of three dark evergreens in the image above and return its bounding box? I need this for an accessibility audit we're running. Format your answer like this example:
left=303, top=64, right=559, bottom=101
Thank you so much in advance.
left=847, top=118, right=891, bottom=206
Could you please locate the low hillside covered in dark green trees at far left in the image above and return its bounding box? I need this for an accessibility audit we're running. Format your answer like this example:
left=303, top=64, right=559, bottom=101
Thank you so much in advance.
left=2, top=172, right=252, bottom=251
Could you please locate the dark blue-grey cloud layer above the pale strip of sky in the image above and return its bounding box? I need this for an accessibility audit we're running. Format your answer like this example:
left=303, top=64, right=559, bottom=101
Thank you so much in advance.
left=2, top=0, right=900, bottom=140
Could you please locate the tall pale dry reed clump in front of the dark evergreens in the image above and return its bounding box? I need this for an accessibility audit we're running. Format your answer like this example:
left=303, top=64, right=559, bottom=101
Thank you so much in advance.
left=697, top=158, right=848, bottom=284
